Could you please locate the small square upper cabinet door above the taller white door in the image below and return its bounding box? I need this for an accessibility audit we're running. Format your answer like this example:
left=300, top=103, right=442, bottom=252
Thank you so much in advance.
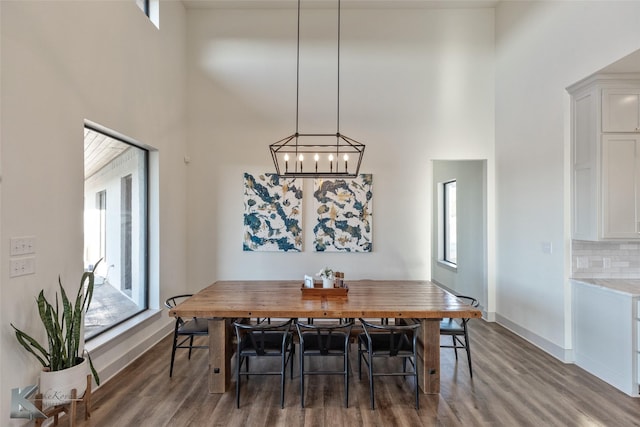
left=602, top=89, right=640, bottom=132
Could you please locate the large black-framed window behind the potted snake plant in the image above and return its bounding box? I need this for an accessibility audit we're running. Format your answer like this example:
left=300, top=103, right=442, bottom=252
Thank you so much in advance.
left=84, top=126, right=148, bottom=339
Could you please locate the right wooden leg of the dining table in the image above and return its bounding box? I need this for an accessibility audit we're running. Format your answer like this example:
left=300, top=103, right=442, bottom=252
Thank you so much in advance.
left=417, top=319, right=440, bottom=394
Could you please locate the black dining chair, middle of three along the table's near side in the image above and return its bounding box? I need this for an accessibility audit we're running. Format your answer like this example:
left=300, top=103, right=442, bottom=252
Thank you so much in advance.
left=296, top=319, right=354, bottom=408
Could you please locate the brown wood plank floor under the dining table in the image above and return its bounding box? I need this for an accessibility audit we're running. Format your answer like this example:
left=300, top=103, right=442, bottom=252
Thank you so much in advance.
left=65, top=320, right=640, bottom=427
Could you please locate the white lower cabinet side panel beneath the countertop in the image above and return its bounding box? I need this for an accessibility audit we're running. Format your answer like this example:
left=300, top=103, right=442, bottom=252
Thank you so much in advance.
left=573, top=281, right=640, bottom=397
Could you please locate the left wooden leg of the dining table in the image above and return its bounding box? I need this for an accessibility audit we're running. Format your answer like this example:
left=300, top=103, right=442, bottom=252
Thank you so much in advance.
left=209, top=317, right=233, bottom=393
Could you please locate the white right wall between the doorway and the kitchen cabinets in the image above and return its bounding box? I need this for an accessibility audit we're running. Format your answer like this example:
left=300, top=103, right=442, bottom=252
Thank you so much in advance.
left=496, top=1, right=640, bottom=360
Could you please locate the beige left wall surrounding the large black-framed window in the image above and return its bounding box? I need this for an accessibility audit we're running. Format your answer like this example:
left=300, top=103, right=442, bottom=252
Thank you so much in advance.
left=0, top=1, right=187, bottom=425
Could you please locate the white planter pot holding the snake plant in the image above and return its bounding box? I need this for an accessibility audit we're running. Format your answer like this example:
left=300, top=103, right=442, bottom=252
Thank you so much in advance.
left=40, top=357, right=89, bottom=408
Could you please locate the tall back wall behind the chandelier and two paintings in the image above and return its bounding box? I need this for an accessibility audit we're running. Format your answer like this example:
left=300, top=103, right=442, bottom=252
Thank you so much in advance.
left=187, top=5, right=494, bottom=288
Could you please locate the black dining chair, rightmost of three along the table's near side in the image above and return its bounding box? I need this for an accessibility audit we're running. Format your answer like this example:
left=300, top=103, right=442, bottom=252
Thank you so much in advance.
left=358, top=319, right=420, bottom=409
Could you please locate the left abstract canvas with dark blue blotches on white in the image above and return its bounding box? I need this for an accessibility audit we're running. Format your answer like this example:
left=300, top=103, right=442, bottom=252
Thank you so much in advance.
left=242, top=173, right=302, bottom=252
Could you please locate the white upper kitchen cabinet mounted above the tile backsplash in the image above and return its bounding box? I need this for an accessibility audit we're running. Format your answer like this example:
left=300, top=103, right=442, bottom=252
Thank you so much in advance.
left=568, top=75, right=640, bottom=241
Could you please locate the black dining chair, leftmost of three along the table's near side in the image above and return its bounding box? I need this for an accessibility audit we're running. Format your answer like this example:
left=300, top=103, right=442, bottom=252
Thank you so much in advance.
left=233, top=319, right=295, bottom=408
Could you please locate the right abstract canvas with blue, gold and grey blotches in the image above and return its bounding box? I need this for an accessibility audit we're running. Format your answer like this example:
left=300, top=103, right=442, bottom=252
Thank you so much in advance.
left=313, top=174, right=373, bottom=252
